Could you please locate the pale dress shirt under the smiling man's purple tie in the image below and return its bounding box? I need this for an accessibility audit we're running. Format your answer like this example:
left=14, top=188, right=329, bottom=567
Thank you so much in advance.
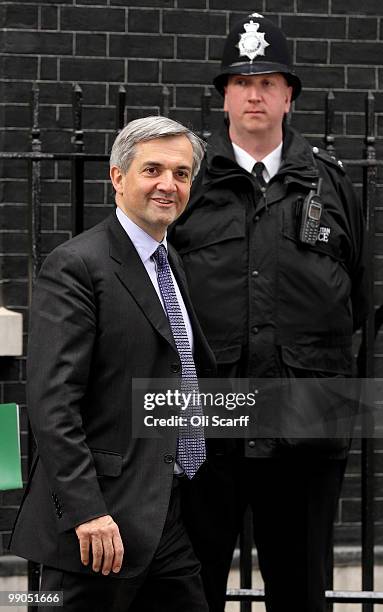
left=116, top=206, right=194, bottom=351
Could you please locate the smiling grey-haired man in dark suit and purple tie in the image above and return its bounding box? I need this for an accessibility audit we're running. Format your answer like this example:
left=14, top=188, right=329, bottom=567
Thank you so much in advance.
left=11, top=117, right=214, bottom=612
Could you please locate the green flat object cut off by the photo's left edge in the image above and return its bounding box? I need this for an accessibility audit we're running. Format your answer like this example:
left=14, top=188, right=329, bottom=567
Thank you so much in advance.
left=0, top=404, right=23, bottom=491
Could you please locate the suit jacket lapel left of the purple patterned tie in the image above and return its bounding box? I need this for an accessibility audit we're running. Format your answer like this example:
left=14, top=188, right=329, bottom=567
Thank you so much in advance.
left=109, top=213, right=177, bottom=350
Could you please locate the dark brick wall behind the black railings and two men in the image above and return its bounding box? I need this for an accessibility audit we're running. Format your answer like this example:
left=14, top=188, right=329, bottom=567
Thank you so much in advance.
left=0, top=0, right=383, bottom=554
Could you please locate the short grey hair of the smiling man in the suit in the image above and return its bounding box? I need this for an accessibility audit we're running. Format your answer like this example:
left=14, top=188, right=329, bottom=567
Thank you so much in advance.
left=110, top=115, right=205, bottom=179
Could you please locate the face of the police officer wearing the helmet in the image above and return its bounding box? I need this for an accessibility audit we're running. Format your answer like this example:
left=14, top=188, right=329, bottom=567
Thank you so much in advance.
left=224, top=73, right=292, bottom=141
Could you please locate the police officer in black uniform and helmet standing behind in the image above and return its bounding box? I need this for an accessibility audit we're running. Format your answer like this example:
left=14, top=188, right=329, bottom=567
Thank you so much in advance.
left=170, top=13, right=365, bottom=612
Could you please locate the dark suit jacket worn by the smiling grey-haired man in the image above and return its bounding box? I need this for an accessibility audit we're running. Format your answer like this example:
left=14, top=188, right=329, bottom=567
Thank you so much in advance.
left=11, top=213, right=214, bottom=578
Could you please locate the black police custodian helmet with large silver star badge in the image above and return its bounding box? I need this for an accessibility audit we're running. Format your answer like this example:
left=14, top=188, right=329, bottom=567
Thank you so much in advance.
left=213, top=13, right=302, bottom=100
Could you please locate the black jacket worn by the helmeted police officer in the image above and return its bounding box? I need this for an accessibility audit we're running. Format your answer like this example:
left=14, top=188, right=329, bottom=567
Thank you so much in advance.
left=169, top=120, right=366, bottom=454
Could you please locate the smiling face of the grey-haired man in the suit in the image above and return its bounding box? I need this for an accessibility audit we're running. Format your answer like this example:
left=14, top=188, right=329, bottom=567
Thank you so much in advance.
left=110, top=134, right=193, bottom=242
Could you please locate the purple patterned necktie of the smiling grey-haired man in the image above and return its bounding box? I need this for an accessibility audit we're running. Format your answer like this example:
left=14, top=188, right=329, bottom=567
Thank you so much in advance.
left=153, top=244, right=206, bottom=478
